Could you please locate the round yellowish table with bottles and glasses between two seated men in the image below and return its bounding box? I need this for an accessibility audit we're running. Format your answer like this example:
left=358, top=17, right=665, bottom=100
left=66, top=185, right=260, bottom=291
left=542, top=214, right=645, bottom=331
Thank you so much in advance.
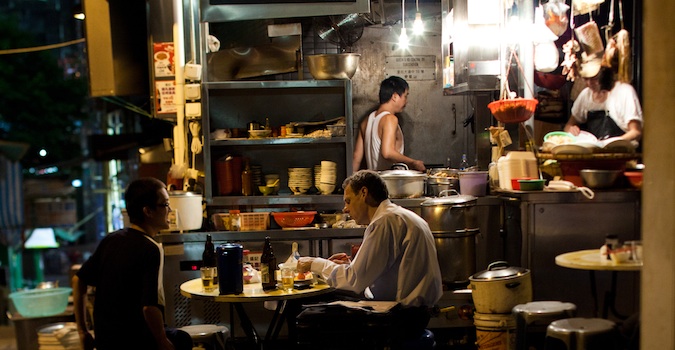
left=180, top=278, right=334, bottom=347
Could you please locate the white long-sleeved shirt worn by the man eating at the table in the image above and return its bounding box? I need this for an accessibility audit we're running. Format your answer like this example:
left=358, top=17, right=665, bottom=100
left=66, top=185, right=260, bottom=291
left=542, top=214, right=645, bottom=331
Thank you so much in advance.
left=312, top=200, right=443, bottom=307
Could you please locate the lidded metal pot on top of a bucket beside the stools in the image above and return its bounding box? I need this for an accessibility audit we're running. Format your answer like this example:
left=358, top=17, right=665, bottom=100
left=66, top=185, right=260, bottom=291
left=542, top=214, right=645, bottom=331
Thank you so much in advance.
left=469, top=261, right=532, bottom=314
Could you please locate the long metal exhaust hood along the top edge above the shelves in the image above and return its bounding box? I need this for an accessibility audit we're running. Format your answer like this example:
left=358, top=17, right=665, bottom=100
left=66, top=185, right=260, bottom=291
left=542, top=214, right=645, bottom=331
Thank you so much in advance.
left=200, top=0, right=370, bottom=22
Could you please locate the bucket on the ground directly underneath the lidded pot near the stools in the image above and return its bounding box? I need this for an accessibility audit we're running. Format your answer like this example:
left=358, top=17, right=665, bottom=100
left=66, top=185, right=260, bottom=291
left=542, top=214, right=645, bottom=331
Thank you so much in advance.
left=473, top=312, right=516, bottom=350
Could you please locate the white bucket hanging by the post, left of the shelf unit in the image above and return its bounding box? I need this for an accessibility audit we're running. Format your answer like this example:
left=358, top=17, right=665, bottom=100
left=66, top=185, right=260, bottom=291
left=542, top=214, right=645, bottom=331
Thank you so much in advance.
left=169, top=191, right=203, bottom=231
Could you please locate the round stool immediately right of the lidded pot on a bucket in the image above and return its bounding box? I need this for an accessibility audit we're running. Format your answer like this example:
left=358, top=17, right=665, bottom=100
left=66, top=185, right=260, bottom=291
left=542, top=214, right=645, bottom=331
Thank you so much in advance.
left=513, top=301, right=577, bottom=350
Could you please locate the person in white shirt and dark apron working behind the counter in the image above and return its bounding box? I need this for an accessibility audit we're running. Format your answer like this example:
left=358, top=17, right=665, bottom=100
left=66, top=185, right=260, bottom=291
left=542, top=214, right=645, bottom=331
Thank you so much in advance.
left=565, top=58, right=642, bottom=142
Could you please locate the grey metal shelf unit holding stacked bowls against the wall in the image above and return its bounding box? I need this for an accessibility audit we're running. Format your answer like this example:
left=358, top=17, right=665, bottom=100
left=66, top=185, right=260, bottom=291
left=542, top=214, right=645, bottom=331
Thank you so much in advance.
left=202, top=80, right=354, bottom=210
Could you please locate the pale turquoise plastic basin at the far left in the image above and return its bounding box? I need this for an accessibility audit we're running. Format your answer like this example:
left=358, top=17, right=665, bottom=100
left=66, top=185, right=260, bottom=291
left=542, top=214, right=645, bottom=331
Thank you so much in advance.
left=9, top=287, right=73, bottom=317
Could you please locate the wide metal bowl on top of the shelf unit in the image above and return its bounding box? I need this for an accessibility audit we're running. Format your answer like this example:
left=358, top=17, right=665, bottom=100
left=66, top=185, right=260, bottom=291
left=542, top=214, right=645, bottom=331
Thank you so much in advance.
left=305, top=53, right=361, bottom=80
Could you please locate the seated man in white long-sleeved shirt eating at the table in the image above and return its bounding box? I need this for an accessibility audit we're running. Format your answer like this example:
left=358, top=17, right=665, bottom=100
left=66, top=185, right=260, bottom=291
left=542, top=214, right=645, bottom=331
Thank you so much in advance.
left=297, top=170, right=443, bottom=340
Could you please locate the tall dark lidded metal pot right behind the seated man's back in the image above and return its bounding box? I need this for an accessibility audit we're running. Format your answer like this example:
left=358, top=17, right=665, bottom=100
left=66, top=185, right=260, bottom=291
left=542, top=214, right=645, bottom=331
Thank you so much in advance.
left=421, top=190, right=480, bottom=289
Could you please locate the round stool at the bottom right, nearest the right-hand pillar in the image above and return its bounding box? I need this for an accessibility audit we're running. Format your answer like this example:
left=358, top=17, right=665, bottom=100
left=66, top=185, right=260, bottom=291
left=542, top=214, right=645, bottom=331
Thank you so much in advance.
left=545, top=318, right=618, bottom=350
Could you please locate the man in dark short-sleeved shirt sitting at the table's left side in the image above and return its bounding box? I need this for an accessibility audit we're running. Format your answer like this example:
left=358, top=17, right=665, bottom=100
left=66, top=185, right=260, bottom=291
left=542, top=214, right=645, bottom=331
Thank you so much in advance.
left=72, top=178, right=192, bottom=350
